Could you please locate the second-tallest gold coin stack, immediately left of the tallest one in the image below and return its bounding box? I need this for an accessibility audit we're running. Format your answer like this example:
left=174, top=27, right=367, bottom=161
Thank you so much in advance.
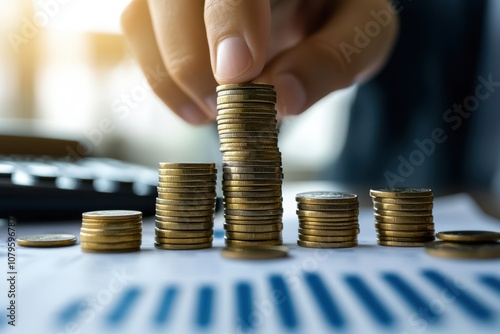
left=155, top=163, right=217, bottom=250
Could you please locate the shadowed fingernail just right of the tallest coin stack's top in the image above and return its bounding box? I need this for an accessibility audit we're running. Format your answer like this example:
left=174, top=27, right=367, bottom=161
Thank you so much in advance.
left=275, top=73, right=307, bottom=115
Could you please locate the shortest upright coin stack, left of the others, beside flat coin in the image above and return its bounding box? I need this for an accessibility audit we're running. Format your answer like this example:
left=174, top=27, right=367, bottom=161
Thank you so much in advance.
left=80, top=210, right=142, bottom=253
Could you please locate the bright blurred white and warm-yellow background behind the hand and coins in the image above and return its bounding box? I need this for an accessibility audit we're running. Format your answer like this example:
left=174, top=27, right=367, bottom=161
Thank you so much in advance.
left=0, top=0, right=355, bottom=180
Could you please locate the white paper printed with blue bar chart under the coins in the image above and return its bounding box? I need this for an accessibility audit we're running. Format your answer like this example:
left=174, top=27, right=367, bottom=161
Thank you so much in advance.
left=0, top=193, right=500, bottom=333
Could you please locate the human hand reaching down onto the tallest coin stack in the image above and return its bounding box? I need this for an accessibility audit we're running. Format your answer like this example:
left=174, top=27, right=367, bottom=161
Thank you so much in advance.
left=122, top=0, right=398, bottom=124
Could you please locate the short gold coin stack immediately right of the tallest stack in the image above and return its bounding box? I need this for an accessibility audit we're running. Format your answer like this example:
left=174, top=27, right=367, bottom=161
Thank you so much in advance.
left=295, top=191, right=359, bottom=248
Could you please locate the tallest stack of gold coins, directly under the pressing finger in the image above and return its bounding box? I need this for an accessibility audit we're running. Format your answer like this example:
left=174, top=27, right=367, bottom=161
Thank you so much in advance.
left=217, top=83, right=283, bottom=247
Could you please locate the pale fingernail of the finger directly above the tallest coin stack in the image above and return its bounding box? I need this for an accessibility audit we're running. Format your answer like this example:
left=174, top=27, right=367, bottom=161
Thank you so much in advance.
left=215, top=36, right=253, bottom=81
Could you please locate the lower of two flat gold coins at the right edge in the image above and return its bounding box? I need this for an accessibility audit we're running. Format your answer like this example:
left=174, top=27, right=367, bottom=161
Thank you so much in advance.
left=425, top=241, right=500, bottom=259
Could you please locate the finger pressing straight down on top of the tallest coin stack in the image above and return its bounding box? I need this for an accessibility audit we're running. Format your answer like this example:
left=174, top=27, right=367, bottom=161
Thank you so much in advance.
left=205, top=0, right=271, bottom=84
